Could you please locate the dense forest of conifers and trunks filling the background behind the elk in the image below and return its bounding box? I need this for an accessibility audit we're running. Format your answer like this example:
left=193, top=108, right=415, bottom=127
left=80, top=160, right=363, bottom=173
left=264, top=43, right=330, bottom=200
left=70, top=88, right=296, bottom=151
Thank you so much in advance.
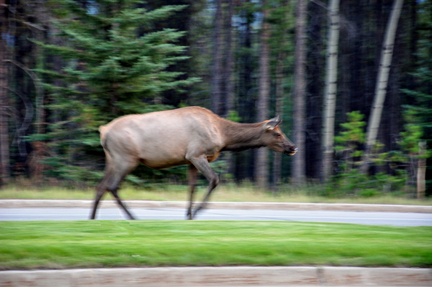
left=0, top=0, right=432, bottom=199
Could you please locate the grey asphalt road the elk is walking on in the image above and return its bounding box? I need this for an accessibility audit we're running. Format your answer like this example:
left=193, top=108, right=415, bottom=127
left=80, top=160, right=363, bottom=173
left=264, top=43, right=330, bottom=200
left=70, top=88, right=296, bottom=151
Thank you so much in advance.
left=0, top=208, right=432, bottom=226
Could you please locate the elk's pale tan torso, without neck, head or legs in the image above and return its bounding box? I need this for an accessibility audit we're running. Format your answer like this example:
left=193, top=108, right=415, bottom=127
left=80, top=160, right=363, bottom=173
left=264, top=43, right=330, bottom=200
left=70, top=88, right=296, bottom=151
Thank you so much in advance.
left=100, top=107, right=223, bottom=169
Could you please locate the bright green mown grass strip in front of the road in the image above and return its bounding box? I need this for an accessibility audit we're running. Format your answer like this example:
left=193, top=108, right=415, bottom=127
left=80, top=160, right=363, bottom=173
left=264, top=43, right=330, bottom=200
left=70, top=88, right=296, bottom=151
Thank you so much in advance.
left=0, top=221, right=432, bottom=270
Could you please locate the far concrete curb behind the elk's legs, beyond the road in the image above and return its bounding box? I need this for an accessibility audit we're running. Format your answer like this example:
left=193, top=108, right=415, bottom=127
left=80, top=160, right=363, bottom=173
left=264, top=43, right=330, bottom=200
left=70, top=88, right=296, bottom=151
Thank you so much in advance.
left=0, top=199, right=432, bottom=213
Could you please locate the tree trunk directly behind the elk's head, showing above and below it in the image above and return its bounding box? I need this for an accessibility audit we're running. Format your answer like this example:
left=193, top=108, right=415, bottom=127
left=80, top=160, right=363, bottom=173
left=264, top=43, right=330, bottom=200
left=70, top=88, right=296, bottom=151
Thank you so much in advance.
left=255, top=1, right=270, bottom=188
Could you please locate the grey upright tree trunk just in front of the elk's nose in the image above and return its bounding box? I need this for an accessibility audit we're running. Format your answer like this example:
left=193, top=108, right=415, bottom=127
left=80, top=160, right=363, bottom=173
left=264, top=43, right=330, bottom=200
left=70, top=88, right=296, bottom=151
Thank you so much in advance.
left=292, top=0, right=307, bottom=184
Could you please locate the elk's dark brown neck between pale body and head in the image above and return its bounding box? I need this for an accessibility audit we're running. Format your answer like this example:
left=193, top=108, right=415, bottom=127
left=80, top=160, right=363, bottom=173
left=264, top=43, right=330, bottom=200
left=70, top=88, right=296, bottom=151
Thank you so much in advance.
left=222, top=121, right=264, bottom=151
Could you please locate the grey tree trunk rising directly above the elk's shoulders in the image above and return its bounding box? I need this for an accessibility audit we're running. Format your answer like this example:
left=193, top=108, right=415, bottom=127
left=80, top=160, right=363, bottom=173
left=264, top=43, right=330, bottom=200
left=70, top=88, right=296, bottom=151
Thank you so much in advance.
left=210, top=0, right=223, bottom=115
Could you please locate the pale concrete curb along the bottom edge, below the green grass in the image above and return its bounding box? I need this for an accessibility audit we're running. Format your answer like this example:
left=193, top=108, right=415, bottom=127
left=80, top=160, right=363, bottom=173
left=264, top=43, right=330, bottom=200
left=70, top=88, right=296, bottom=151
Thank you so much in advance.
left=0, top=266, right=432, bottom=287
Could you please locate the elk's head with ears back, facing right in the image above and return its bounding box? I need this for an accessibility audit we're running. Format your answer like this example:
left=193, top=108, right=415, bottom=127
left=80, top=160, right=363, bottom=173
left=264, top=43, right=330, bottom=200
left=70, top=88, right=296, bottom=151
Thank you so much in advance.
left=263, top=116, right=297, bottom=155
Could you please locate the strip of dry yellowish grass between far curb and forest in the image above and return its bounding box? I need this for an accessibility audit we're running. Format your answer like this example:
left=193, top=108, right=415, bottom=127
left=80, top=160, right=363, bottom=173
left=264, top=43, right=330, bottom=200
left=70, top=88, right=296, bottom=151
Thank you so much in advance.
left=0, top=183, right=432, bottom=205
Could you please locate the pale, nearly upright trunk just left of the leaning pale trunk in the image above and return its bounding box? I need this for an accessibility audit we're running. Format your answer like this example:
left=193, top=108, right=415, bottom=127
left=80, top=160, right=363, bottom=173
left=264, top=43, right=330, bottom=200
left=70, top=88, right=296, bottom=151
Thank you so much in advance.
left=322, top=0, right=340, bottom=181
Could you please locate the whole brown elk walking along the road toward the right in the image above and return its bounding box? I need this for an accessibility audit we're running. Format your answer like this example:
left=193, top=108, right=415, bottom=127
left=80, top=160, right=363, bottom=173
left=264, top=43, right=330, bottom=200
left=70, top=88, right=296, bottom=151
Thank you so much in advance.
left=90, top=107, right=297, bottom=222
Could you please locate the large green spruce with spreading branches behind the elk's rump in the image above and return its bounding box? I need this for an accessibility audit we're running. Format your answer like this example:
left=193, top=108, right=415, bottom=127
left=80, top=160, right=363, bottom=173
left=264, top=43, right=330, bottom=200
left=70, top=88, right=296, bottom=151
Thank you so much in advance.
left=33, top=0, right=196, bottom=183
